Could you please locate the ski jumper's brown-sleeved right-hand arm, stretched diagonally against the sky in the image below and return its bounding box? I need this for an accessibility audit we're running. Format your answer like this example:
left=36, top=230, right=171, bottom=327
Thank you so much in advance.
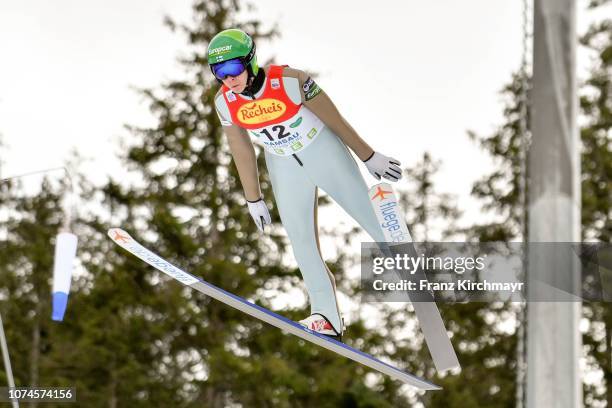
left=283, top=67, right=374, bottom=161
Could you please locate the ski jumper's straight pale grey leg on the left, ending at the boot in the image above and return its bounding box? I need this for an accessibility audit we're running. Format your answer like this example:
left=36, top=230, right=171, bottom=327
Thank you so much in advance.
left=265, top=149, right=342, bottom=332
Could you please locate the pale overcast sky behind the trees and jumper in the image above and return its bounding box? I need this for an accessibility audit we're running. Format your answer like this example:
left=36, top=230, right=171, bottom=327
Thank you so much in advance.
left=0, top=0, right=604, bottom=236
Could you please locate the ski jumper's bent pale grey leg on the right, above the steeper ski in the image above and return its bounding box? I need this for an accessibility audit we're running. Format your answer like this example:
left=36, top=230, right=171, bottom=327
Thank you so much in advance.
left=299, top=128, right=385, bottom=243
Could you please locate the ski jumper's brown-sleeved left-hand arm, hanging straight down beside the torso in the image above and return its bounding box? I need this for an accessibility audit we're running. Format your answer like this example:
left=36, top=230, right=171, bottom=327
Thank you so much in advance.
left=215, top=93, right=261, bottom=201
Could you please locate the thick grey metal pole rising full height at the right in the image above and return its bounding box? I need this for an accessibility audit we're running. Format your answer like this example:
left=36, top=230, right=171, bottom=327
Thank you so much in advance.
left=527, top=0, right=582, bottom=408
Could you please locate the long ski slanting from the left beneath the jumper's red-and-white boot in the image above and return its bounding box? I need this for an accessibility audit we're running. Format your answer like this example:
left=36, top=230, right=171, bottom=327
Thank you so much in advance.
left=108, top=228, right=441, bottom=390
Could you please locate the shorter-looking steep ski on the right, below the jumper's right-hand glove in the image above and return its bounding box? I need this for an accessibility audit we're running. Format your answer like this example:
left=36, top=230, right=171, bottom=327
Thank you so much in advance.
left=370, top=183, right=460, bottom=372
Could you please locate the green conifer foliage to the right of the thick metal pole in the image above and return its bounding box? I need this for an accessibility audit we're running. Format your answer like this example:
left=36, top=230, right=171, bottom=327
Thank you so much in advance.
left=580, top=0, right=612, bottom=406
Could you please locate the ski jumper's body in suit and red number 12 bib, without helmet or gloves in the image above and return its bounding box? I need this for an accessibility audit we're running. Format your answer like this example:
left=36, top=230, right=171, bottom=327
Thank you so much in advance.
left=215, top=65, right=385, bottom=333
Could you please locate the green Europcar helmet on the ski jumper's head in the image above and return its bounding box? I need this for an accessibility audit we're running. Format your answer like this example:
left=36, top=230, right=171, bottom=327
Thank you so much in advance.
left=206, top=28, right=259, bottom=76
